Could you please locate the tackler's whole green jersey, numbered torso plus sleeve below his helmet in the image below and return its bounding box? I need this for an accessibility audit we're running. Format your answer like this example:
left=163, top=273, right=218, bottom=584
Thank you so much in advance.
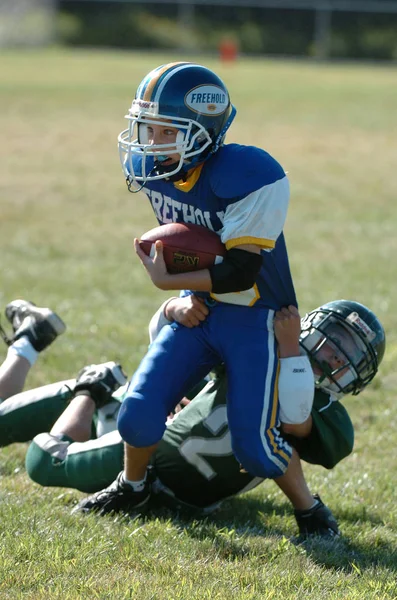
left=153, top=376, right=354, bottom=507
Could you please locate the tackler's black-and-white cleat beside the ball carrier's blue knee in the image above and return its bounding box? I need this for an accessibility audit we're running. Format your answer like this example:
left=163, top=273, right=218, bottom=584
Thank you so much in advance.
left=74, top=362, right=127, bottom=408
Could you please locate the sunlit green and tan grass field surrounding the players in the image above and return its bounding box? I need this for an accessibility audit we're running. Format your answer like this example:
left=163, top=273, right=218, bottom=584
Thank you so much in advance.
left=0, top=50, right=397, bottom=600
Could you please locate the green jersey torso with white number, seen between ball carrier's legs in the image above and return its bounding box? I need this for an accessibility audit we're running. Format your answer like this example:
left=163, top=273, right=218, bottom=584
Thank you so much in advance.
left=153, top=377, right=262, bottom=507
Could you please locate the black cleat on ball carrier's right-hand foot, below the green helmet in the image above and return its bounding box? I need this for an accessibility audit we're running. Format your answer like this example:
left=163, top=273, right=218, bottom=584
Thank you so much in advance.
left=294, top=494, right=340, bottom=538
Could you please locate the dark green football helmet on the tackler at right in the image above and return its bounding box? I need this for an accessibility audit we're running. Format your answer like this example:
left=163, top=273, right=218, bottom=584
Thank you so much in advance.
left=299, top=300, right=386, bottom=396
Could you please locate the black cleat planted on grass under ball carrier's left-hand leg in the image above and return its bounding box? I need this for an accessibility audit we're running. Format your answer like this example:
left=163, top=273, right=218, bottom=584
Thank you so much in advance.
left=72, top=471, right=151, bottom=515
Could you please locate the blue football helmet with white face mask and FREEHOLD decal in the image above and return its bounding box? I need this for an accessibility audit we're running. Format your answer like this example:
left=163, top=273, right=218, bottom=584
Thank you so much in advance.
left=118, top=62, right=236, bottom=191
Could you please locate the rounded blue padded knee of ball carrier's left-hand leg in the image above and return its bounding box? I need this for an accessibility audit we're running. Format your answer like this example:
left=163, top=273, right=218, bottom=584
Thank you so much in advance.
left=117, top=396, right=167, bottom=448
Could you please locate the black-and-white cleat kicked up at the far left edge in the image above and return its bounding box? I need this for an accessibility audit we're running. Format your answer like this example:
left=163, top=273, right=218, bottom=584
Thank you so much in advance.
left=5, top=300, right=66, bottom=352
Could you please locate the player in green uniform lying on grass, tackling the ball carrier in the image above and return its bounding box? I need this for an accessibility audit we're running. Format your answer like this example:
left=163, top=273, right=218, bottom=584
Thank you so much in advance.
left=0, top=298, right=385, bottom=536
